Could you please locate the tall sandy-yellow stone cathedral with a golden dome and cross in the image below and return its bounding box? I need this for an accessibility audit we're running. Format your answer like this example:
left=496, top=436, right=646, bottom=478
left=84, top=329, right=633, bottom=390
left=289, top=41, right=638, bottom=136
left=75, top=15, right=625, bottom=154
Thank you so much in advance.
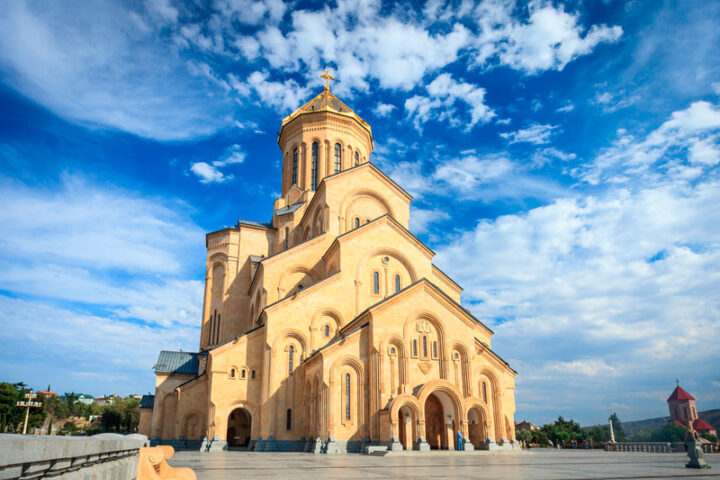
left=140, top=71, right=516, bottom=454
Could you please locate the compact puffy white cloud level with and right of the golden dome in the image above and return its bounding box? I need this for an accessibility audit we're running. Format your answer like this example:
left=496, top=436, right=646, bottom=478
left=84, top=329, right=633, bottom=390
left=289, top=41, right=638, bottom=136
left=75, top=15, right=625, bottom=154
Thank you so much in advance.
left=405, top=73, right=495, bottom=132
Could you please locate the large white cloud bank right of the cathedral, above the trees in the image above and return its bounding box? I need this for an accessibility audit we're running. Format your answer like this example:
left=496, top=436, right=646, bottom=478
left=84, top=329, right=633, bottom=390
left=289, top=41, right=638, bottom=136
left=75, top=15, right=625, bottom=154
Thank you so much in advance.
left=436, top=179, right=720, bottom=424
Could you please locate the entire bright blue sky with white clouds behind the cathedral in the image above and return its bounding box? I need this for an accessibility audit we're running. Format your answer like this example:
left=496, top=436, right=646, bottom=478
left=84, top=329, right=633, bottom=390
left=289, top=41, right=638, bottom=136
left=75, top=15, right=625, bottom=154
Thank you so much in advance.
left=0, top=0, right=720, bottom=424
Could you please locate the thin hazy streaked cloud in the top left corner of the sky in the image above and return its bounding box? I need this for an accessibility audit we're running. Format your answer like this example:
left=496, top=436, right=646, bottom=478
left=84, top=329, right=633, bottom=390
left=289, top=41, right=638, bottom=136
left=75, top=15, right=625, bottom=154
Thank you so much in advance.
left=0, top=1, right=230, bottom=140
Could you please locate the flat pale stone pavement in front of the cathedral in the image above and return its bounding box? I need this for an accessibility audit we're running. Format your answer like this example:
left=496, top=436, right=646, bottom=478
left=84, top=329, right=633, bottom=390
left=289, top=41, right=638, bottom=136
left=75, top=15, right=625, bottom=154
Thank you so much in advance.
left=170, top=449, right=720, bottom=480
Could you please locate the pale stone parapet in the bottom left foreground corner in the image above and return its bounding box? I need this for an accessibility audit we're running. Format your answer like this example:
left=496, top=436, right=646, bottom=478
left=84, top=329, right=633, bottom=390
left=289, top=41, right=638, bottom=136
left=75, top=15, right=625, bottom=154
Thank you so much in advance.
left=0, top=433, right=148, bottom=480
